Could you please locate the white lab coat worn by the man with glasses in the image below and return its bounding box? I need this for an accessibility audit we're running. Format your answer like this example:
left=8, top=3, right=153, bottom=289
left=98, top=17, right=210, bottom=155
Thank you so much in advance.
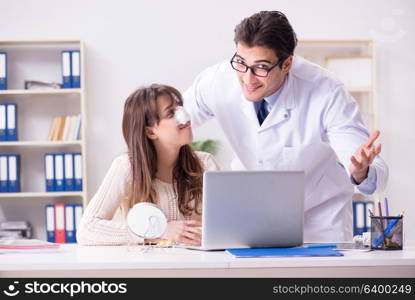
left=183, top=56, right=388, bottom=241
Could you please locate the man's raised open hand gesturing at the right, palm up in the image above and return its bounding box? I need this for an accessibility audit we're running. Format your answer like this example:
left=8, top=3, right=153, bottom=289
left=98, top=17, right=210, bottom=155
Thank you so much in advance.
left=349, top=130, right=382, bottom=184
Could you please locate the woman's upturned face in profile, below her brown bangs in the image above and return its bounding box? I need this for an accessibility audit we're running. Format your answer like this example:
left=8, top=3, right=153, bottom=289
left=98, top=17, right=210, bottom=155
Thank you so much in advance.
left=149, top=95, right=193, bottom=148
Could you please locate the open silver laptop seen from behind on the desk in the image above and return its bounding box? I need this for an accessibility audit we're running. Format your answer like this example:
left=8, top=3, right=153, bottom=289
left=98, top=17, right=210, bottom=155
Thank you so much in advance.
left=181, top=171, right=304, bottom=250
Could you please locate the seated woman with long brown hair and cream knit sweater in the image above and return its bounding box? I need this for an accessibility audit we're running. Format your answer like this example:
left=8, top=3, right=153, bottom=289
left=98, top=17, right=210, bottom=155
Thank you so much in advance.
left=77, top=84, right=217, bottom=245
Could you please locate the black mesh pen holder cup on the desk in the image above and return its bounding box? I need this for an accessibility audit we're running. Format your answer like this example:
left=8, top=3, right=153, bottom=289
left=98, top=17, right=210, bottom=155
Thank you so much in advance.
left=370, top=216, right=403, bottom=250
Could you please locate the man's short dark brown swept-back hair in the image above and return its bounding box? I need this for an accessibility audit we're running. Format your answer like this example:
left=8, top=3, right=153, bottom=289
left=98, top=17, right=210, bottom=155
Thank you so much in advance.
left=234, top=11, right=297, bottom=67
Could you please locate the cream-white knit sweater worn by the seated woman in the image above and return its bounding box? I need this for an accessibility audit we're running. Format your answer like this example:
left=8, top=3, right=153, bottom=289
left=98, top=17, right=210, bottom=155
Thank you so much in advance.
left=76, top=152, right=218, bottom=245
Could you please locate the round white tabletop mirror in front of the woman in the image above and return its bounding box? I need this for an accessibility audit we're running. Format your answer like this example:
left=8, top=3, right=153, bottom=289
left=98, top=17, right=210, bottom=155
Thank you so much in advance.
left=127, top=202, right=167, bottom=239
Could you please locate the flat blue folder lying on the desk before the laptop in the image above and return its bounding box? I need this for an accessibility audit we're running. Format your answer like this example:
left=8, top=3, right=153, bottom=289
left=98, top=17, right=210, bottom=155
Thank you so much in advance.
left=226, top=248, right=343, bottom=257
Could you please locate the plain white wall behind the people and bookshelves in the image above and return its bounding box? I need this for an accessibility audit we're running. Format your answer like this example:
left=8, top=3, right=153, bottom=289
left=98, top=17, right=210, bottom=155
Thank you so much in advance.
left=0, top=0, right=415, bottom=240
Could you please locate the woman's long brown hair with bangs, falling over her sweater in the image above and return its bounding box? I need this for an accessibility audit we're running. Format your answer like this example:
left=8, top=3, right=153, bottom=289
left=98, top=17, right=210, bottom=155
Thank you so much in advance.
left=122, top=84, right=203, bottom=216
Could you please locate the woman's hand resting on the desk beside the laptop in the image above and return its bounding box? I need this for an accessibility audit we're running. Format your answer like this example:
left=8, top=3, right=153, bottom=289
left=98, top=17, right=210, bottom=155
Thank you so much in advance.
left=161, top=220, right=202, bottom=246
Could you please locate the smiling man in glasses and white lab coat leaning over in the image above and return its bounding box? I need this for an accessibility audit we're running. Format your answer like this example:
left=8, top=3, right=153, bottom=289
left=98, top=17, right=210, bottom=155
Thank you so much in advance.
left=184, top=11, right=388, bottom=241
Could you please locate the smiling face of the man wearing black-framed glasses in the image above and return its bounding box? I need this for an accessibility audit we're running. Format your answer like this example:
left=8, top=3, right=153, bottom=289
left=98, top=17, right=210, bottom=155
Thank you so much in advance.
left=233, top=43, right=292, bottom=102
